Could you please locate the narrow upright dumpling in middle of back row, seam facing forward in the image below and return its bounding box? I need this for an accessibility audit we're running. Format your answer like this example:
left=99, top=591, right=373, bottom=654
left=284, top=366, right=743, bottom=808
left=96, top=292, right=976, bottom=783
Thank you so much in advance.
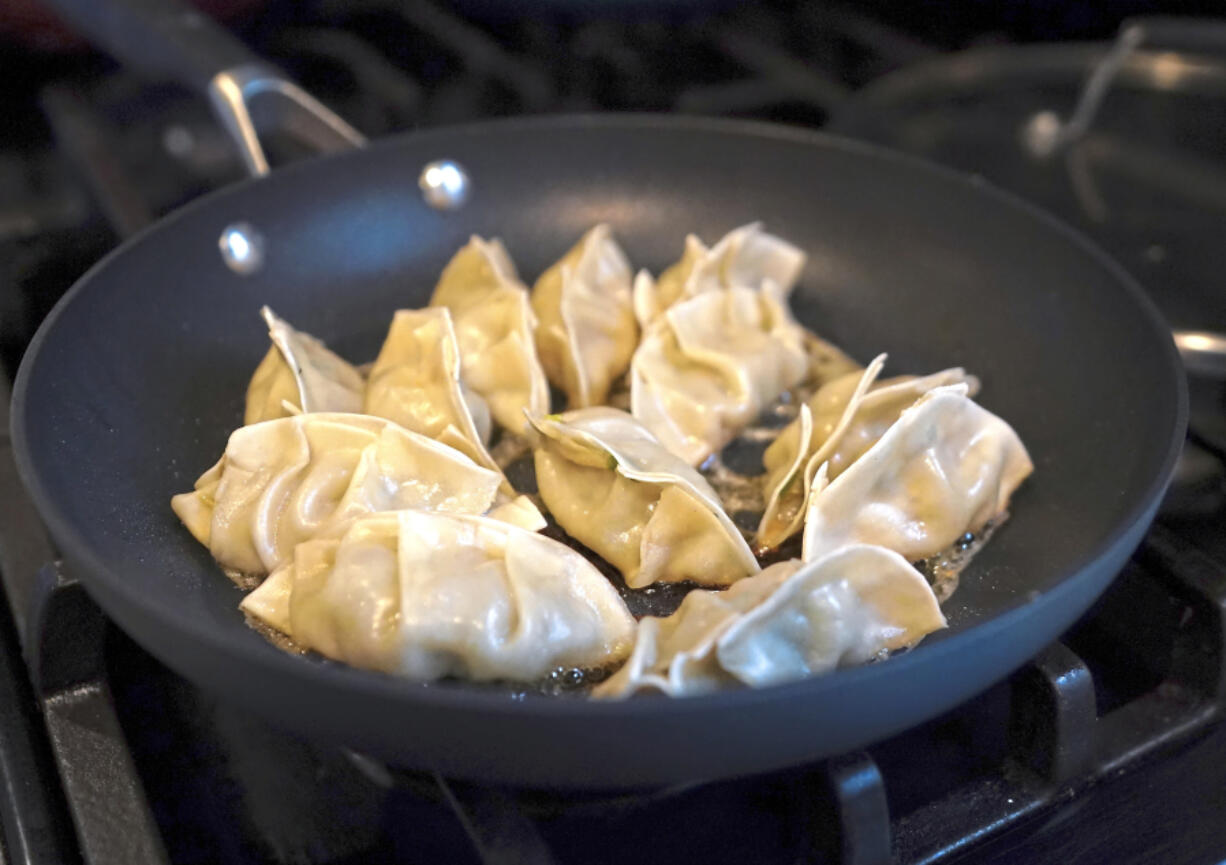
left=532, top=224, right=639, bottom=408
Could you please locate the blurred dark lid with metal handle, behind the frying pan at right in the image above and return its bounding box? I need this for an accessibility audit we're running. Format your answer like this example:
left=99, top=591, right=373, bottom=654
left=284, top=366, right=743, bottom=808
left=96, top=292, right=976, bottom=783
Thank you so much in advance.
left=828, top=18, right=1226, bottom=338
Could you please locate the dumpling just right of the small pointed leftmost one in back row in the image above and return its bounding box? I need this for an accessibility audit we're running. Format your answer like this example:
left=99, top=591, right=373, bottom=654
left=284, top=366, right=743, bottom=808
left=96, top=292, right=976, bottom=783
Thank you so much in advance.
left=364, top=306, right=500, bottom=472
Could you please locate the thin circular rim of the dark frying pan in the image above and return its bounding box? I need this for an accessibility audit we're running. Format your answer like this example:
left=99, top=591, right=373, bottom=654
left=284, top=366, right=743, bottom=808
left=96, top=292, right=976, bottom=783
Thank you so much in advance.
left=10, top=114, right=1188, bottom=720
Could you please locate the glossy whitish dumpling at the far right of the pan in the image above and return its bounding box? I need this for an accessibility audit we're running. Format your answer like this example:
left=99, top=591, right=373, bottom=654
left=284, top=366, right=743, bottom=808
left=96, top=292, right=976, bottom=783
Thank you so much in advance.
left=803, top=383, right=1034, bottom=561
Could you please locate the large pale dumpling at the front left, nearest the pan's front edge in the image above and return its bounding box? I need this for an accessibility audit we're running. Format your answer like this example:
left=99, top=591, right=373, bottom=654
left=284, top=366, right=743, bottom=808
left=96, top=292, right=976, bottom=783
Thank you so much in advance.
left=242, top=510, right=635, bottom=681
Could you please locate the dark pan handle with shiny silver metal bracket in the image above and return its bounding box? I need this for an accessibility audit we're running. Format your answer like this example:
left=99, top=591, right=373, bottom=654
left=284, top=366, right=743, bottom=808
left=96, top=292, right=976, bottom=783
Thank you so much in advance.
left=49, top=0, right=365, bottom=176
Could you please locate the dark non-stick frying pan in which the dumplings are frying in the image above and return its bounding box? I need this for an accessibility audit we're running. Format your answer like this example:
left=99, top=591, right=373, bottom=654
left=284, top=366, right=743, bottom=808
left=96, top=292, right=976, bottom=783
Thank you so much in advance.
left=12, top=0, right=1186, bottom=789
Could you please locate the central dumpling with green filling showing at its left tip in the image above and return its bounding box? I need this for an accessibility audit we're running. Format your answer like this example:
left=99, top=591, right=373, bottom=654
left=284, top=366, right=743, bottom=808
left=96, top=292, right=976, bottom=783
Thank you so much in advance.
left=532, top=408, right=759, bottom=588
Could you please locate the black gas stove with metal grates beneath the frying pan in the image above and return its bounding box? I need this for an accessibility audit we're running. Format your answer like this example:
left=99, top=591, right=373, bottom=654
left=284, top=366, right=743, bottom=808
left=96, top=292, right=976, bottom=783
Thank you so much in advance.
left=0, top=0, right=1226, bottom=865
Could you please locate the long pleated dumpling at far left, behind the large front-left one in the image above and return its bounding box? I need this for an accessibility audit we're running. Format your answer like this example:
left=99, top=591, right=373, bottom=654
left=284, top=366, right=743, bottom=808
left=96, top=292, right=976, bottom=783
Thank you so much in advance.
left=170, top=413, right=501, bottom=577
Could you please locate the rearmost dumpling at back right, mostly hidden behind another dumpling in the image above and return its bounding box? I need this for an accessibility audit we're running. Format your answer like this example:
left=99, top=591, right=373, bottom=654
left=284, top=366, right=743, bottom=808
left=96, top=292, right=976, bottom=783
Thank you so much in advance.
left=634, top=222, right=805, bottom=328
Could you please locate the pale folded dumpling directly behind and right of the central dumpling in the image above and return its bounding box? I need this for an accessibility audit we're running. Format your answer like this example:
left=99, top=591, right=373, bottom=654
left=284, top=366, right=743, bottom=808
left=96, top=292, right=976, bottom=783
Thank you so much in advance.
left=630, top=282, right=808, bottom=466
